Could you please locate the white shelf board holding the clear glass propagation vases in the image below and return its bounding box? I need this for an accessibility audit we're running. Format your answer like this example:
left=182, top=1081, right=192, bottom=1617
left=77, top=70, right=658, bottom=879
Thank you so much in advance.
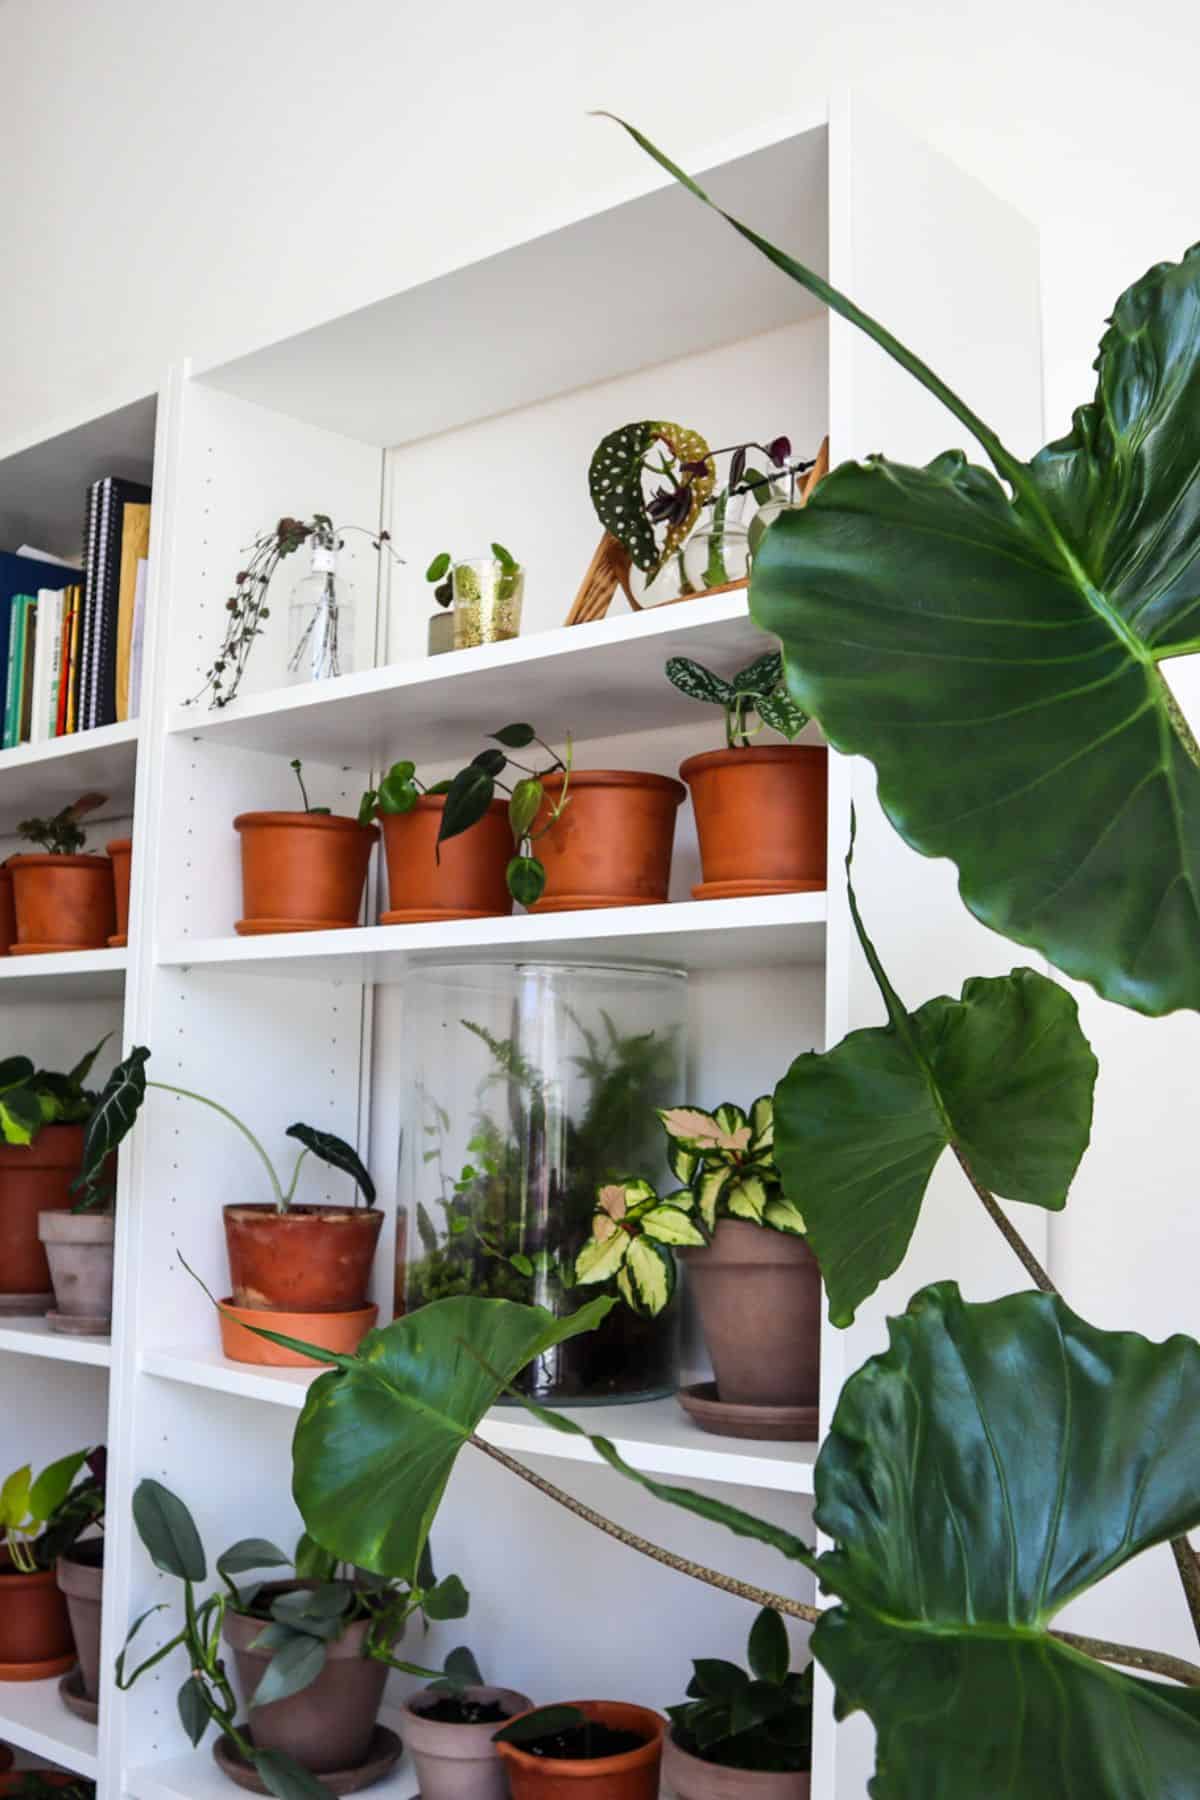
left=171, top=590, right=770, bottom=767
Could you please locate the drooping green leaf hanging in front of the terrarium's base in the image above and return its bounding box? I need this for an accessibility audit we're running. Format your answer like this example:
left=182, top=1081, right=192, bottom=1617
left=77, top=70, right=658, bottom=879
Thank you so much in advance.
left=293, top=1300, right=613, bottom=1580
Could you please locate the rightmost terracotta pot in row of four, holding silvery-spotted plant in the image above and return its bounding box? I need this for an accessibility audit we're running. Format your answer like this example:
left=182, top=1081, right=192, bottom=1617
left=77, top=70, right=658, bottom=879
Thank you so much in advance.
left=680, top=743, right=829, bottom=900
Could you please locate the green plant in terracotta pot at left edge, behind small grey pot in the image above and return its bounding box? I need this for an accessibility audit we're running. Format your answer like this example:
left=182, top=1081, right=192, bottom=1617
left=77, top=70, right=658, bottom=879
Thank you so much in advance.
left=0, top=1039, right=106, bottom=1318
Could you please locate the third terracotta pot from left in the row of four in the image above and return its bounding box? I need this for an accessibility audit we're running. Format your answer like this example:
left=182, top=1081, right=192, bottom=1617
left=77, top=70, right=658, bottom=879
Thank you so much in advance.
left=533, top=769, right=684, bottom=913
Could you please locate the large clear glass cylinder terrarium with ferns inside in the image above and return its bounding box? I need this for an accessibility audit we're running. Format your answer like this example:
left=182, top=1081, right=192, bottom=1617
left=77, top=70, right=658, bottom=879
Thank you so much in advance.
left=398, top=963, right=687, bottom=1404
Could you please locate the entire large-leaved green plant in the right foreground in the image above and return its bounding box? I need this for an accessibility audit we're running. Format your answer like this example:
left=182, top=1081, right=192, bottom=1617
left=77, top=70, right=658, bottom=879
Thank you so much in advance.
left=227, top=128, right=1200, bottom=1800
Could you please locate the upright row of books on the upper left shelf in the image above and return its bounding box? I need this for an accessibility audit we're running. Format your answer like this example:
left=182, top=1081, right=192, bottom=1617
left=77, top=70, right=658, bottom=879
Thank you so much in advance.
left=0, top=475, right=149, bottom=751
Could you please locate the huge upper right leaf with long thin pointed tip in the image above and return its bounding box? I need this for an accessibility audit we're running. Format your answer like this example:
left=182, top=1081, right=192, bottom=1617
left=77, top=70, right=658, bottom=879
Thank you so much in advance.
left=604, top=126, right=1200, bottom=1013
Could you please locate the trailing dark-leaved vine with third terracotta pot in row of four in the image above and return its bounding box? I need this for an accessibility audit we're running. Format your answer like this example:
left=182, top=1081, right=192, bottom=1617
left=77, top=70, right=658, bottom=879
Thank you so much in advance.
left=437, top=724, right=684, bottom=913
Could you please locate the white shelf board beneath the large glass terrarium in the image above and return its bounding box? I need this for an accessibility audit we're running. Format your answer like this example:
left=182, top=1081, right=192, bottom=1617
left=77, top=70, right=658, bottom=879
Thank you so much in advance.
left=140, top=1350, right=817, bottom=1494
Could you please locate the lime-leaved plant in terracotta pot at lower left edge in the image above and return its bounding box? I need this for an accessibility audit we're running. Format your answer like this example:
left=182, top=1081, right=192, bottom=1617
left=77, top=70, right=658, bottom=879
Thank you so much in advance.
left=0, top=1451, right=104, bottom=1681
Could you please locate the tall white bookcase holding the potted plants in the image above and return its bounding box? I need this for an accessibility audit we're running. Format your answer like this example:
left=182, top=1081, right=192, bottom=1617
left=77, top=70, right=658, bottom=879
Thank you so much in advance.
left=0, top=103, right=1040, bottom=1800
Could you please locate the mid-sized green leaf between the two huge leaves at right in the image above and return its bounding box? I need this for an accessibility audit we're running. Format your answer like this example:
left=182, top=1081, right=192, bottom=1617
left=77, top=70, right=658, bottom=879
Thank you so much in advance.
left=775, top=835, right=1097, bottom=1325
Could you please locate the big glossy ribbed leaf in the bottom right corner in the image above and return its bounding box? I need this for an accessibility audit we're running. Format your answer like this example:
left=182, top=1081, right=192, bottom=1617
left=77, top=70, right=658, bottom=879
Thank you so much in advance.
left=813, top=1282, right=1200, bottom=1800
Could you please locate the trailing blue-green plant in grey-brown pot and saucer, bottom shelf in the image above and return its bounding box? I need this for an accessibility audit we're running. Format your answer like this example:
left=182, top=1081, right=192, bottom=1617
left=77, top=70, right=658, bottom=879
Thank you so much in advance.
left=117, top=1480, right=456, bottom=1800
